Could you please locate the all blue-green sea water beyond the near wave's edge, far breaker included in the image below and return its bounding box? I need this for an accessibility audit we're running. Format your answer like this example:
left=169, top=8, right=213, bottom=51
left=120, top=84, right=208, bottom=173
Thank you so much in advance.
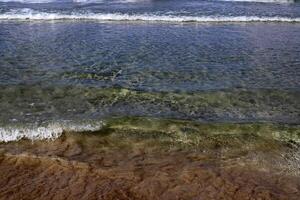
left=0, top=0, right=300, bottom=139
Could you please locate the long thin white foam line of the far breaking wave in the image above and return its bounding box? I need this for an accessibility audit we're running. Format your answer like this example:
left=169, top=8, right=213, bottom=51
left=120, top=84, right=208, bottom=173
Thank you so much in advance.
left=0, top=8, right=300, bottom=22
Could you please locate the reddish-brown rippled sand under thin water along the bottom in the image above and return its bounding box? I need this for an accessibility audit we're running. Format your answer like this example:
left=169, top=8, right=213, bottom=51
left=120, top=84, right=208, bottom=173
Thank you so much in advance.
left=0, top=131, right=300, bottom=200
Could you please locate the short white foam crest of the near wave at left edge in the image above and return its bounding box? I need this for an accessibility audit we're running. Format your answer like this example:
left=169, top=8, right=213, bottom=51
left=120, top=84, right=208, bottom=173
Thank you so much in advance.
left=0, top=122, right=104, bottom=142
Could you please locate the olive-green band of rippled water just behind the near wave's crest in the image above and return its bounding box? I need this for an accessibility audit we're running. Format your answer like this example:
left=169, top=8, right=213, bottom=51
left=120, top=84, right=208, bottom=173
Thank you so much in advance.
left=0, top=86, right=300, bottom=124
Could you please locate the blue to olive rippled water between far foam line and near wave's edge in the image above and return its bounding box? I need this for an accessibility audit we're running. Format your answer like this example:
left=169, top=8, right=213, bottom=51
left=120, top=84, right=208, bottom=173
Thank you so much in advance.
left=0, top=21, right=300, bottom=140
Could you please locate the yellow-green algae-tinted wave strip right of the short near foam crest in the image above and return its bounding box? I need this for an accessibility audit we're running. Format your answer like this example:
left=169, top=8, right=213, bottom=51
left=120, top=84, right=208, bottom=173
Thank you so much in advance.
left=73, top=117, right=300, bottom=152
